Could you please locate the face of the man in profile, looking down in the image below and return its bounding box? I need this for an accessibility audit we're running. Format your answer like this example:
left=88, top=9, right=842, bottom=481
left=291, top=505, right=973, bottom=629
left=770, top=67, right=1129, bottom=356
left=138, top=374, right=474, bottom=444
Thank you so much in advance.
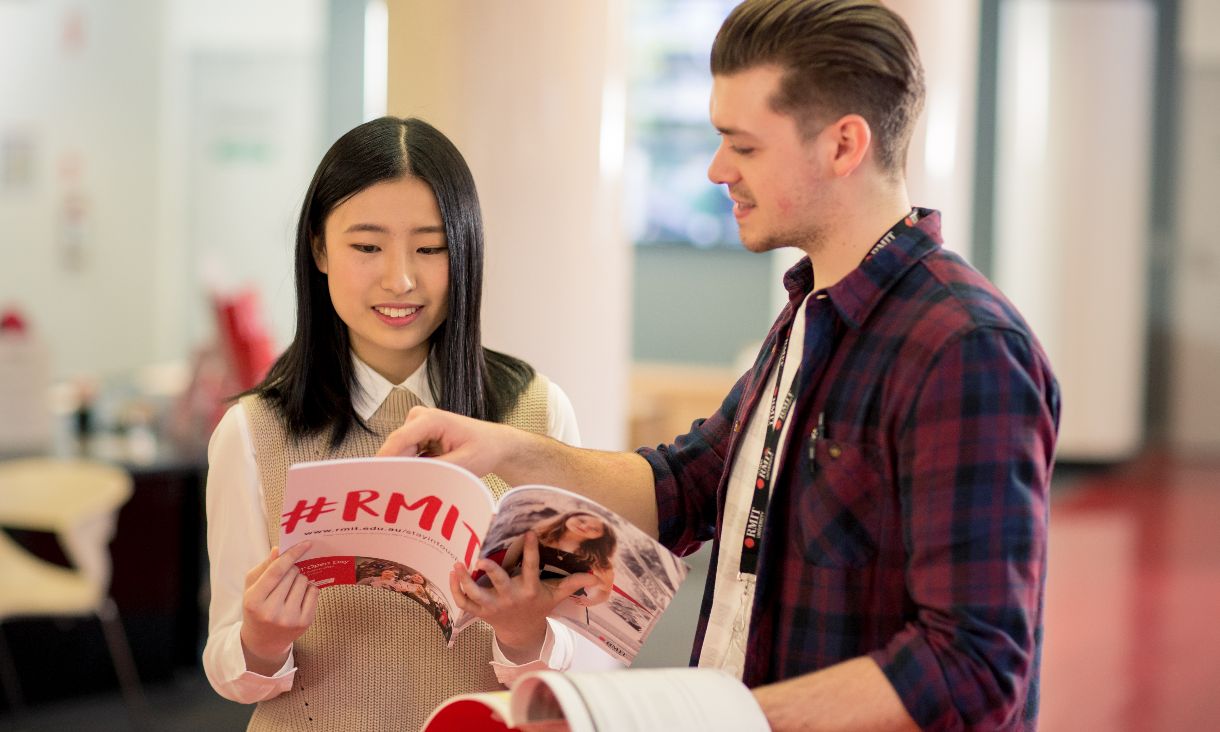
left=708, top=66, right=832, bottom=254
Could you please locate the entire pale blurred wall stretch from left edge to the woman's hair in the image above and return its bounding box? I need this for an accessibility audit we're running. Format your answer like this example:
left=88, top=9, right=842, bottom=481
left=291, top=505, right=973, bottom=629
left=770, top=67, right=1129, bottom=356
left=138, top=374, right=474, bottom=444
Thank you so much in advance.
left=0, top=0, right=326, bottom=385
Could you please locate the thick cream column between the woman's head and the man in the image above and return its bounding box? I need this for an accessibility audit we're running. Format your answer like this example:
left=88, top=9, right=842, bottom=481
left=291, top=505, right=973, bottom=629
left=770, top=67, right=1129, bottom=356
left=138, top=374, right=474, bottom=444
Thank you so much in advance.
left=388, top=0, right=631, bottom=449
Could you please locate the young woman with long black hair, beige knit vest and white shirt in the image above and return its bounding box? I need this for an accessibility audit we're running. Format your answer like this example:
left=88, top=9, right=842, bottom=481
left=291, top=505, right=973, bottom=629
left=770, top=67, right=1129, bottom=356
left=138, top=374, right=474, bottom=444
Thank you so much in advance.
left=204, top=117, right=597, bottom=731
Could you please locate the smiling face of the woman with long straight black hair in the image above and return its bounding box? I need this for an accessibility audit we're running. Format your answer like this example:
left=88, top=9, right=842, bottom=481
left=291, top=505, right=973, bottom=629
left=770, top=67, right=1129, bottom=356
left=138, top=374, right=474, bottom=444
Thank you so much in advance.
left=315, top=177, right=449, bottom=384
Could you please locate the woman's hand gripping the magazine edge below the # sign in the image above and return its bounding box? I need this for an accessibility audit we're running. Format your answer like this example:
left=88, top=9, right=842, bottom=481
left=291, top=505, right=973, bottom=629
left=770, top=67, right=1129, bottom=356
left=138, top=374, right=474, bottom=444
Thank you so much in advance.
left=242, top=542, right=318, bottom=676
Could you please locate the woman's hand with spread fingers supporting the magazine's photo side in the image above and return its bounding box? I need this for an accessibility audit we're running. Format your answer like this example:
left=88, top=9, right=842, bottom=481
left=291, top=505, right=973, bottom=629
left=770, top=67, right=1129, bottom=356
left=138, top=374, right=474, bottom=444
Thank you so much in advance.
left=449, top=531, right=599, bottom=664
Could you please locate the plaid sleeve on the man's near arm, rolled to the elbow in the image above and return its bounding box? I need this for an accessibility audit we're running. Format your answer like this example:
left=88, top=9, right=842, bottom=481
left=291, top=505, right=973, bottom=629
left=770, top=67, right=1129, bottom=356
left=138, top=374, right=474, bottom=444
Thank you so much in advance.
left=871, top=328, right=1059, bottom=730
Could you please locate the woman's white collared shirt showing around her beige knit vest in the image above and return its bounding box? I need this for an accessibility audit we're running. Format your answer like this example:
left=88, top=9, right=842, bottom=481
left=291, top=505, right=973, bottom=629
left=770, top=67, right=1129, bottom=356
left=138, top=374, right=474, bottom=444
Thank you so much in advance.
left=204, top=355, right=621, bottom=704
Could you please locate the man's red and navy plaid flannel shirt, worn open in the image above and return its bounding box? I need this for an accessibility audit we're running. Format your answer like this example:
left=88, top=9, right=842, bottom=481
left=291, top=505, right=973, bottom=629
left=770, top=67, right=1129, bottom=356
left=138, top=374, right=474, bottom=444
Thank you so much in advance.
left=639, top=210, right=1059, bottom=730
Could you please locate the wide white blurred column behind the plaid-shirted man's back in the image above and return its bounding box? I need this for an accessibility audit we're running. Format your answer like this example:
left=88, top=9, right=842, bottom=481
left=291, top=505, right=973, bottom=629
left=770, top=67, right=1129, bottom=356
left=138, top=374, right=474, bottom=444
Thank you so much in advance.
left=993, top=0, right=1158, bottom=461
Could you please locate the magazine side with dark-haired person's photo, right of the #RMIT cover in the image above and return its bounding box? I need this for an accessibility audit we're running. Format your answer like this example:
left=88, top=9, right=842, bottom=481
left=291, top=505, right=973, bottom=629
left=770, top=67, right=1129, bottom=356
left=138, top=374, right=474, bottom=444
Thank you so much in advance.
left=473, top=486, right=688, bottom=665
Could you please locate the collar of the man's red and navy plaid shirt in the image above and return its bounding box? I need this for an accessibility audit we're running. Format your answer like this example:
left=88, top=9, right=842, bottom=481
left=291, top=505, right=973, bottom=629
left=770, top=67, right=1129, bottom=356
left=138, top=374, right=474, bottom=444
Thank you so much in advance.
left=783, top=209, right=942, bottom=328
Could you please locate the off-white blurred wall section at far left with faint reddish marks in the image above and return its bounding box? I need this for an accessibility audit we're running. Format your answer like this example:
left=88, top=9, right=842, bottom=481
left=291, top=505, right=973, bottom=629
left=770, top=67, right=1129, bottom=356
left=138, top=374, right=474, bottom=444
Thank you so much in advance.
left=0, top=0, right=166, bottom=373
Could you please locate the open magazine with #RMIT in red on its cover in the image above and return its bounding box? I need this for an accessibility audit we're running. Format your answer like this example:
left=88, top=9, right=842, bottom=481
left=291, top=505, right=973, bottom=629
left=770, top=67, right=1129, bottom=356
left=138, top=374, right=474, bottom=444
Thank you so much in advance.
left=279, top=458, right=688, bottom=664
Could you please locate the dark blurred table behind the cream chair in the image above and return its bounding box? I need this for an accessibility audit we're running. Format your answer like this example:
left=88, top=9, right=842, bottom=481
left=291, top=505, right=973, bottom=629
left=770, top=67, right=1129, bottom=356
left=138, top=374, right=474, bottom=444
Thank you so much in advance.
left=0, top=434, right=207, bottom=708
